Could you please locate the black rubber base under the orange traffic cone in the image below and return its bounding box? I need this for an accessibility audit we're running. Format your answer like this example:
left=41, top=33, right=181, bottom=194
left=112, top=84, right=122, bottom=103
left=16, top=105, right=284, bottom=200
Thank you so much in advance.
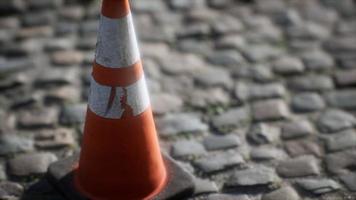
left=47, top=155, right=194, bottom=200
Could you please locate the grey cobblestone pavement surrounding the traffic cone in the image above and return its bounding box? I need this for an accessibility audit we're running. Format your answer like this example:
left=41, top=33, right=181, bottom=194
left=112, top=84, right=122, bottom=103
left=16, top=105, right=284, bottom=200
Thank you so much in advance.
left=0, top=0, right=356, bottom=200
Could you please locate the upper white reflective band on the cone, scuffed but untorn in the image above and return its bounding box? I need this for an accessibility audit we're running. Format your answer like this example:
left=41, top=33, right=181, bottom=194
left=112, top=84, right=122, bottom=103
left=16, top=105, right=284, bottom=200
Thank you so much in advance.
left=95, top=13, right=140, bottom=68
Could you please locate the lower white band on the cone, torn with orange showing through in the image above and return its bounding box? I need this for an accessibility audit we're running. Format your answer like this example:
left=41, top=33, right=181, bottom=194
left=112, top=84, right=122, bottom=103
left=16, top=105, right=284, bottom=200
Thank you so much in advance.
left=89, top=76, right=150, bottom=119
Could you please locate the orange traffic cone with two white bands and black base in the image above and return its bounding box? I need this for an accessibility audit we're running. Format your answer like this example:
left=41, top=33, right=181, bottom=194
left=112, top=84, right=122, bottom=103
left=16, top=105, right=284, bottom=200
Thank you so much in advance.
left=47, top=0, right=194, bottom=200
